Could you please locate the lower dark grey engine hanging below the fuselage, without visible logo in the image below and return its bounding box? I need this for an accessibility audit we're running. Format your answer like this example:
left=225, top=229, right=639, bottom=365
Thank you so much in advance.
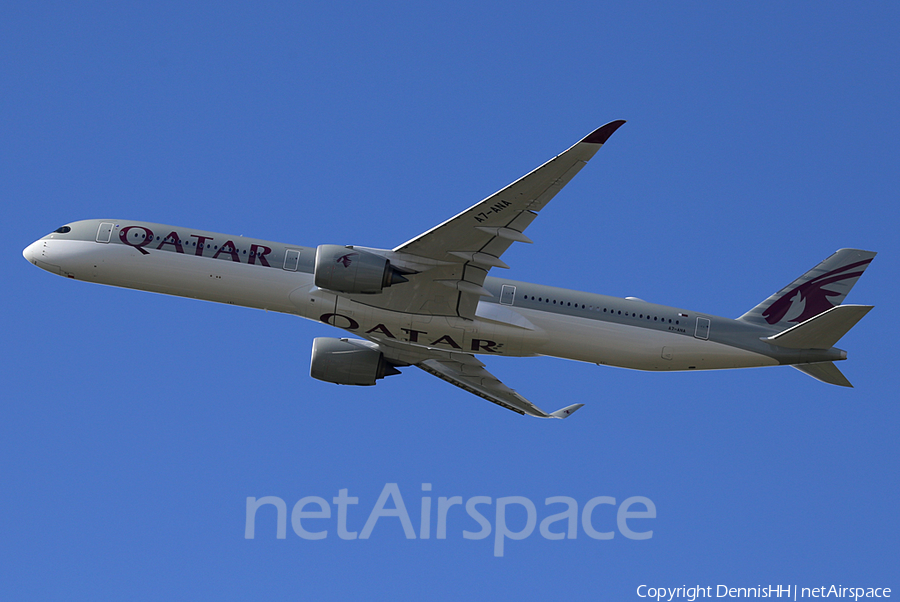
left=309, top=337, right=400, bottom=386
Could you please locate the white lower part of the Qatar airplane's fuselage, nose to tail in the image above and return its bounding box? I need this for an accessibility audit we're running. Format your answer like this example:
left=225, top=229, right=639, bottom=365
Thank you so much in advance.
left=23, top=229, right=779, bottom=371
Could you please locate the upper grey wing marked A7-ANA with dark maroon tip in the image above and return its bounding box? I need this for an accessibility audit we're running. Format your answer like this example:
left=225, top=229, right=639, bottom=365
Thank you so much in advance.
left=346, top=120, right=625, bottom=319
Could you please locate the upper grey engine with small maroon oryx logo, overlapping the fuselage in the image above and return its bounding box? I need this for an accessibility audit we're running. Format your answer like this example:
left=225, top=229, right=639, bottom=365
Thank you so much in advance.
left=315, top=245, right=407, bottom=294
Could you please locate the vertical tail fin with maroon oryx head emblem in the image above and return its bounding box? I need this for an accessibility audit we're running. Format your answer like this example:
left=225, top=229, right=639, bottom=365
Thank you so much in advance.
left=738, top=249, right=876, bottom=330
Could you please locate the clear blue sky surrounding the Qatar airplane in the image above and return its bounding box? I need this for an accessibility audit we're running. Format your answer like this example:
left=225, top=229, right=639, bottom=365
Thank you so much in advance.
left=0, top=2, right=900, bottom=600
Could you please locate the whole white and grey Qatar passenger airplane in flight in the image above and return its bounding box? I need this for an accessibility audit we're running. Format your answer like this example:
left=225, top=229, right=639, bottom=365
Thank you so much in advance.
left=23, top=120, right=875, bottom=418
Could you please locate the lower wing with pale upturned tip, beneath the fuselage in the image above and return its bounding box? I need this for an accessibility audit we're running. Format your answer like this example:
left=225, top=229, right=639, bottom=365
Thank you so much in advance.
left=365, top=341, right=584, bottom=418
